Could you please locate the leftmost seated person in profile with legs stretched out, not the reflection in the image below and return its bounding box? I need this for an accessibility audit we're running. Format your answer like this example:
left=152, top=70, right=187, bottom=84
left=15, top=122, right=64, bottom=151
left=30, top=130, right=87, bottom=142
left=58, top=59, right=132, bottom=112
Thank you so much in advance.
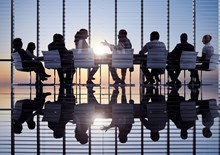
left=13, top=38, right=50, bottom=84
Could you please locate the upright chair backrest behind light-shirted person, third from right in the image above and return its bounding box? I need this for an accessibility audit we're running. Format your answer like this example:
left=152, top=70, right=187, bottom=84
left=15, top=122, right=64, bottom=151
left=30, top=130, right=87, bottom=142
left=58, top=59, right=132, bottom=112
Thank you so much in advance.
left=147, top=48, right=168, bottom=69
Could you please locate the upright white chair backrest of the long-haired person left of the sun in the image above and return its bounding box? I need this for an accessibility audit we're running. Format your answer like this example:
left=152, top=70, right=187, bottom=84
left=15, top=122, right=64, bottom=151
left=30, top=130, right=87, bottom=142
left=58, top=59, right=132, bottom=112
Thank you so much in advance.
left=73, top=48, right=95, bottom=68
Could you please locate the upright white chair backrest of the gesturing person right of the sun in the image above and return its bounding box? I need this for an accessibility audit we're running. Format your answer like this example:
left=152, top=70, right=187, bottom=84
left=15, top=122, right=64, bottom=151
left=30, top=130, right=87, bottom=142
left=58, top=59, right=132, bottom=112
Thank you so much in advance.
left=112, top=49, right=134, bottom=68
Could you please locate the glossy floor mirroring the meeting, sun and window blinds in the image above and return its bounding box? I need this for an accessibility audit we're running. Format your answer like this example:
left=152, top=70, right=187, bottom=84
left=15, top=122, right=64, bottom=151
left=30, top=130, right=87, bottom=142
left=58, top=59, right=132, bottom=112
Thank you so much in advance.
left=0, top=85, right=220, bottom=155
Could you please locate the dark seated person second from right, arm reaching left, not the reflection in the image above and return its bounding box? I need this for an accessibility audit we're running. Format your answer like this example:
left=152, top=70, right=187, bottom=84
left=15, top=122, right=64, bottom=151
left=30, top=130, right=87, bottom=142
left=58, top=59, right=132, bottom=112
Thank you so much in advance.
left=167, top=33, right=195, bottom=85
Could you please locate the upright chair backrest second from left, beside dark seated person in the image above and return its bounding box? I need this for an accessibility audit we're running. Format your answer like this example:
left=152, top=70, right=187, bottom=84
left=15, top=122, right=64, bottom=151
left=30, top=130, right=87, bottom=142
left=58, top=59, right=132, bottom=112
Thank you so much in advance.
left=42, top=50, right=62, bottom=69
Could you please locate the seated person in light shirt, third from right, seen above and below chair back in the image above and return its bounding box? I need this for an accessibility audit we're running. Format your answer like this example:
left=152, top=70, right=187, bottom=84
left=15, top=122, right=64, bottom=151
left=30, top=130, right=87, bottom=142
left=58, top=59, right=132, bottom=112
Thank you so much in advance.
left=139, top=31, right=166, bottom=84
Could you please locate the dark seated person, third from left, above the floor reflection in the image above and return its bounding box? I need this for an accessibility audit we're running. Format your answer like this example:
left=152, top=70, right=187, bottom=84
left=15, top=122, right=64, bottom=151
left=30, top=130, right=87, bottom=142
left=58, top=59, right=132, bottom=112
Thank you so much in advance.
left=48, top=34, right=75, bottom=84
